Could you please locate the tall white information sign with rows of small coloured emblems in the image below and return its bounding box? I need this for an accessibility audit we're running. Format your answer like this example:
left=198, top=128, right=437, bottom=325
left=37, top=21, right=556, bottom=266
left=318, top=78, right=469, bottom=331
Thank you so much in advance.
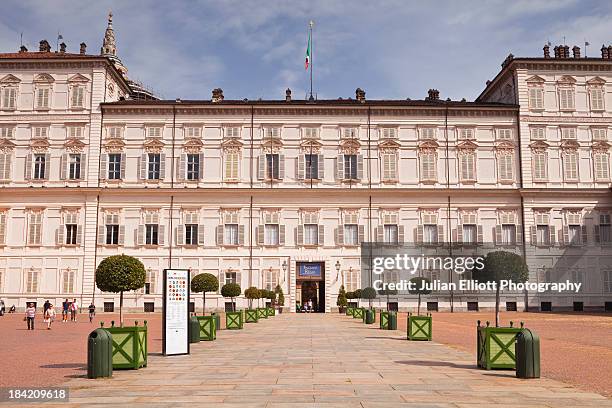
left=162, top=269, right=190, bottom=356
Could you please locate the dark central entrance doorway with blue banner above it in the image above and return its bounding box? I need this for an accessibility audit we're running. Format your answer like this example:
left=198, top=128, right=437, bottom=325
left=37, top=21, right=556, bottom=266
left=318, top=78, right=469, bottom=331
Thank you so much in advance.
left=295, top=262, right=325, bottom=313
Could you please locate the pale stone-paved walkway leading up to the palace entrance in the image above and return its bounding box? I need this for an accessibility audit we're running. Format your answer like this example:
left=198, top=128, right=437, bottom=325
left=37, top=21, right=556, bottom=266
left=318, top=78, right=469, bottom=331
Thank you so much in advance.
left=20, top=314, right=612, bottom=408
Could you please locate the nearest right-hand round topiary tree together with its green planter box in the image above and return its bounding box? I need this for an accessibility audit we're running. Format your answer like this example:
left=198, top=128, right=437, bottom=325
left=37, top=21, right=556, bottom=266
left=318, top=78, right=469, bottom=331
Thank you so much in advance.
left=472, top=251, right=529, bottom=370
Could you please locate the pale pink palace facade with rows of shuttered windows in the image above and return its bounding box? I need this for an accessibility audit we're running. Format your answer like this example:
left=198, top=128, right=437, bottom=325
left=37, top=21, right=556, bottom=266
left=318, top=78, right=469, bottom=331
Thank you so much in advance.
left=0, top=17, right=612, bottom=311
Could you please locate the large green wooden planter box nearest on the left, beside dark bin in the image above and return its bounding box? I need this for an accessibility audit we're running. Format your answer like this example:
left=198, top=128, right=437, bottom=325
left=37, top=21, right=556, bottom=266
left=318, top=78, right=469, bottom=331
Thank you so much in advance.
left=102, top=320, right=147, bottom=369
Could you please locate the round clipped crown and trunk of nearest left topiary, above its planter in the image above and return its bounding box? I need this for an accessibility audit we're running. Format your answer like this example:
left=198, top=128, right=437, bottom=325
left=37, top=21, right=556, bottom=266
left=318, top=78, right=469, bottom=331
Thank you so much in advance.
left=96, top=254, right=147, bottom=326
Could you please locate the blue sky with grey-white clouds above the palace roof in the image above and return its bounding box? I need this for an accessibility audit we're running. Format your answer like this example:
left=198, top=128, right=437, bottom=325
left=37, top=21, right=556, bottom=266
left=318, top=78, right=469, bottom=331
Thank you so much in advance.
left=0, top=0, right=612, bottom=100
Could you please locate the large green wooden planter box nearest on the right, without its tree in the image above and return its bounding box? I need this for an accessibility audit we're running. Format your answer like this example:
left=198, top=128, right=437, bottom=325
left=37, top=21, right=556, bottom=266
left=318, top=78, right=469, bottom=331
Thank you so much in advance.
left=476, top=320, right=523, bottom=370
